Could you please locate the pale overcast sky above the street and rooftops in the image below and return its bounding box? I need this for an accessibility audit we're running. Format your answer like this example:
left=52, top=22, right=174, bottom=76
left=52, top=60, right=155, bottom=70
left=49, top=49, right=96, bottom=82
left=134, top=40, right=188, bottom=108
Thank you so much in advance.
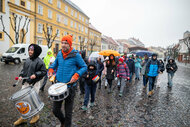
left=71, top=0, right=190, bottom=47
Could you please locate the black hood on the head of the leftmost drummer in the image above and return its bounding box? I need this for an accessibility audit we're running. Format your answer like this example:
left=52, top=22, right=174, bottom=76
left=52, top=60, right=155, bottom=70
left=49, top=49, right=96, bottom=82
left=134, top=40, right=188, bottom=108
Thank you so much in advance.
left=28, top=44, right=42, bottom=60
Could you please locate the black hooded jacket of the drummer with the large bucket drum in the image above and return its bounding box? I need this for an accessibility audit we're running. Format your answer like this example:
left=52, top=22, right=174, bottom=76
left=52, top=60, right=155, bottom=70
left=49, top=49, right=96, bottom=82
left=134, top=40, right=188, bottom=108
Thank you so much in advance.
left=19, top=44, right=46, bottom=85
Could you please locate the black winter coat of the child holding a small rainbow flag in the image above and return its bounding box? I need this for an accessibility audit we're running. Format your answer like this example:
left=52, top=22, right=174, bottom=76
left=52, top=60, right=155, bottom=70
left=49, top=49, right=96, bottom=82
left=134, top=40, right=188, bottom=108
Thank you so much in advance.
left=84, top=62, right=97, bottom=85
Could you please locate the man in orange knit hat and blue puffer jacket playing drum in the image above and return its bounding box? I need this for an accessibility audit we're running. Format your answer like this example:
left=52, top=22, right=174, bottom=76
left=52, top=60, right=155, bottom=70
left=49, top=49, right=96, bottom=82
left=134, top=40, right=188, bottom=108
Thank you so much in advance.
left=49, top=35, right=87, bottom=127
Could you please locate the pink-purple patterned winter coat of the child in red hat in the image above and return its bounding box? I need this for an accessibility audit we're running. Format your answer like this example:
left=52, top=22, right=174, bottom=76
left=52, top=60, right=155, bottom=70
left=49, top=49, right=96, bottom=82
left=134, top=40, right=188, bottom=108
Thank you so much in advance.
left=117, top=63, right=130, bottom=79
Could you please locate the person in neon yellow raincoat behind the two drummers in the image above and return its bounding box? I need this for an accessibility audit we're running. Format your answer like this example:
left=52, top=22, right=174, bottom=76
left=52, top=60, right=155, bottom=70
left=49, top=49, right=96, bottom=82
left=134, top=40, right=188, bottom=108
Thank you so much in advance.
left=40, top=49, right=55, bottom=91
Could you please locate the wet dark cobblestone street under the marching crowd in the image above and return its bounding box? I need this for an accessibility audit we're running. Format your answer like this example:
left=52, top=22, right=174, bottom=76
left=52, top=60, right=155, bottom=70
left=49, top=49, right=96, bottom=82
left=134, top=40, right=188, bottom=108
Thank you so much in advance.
left=0, top=63, right=190, bottom=127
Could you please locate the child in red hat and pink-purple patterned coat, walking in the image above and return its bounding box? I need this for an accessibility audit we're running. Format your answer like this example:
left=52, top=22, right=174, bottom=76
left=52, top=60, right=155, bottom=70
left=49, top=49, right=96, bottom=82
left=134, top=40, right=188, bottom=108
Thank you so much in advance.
left=117, top=58, right=130, bottom=97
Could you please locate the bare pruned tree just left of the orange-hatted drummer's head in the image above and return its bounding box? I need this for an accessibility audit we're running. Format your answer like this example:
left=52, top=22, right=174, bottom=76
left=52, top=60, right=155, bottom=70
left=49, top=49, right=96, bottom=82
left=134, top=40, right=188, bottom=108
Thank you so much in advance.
left=43, top=23, right=58, bottom=48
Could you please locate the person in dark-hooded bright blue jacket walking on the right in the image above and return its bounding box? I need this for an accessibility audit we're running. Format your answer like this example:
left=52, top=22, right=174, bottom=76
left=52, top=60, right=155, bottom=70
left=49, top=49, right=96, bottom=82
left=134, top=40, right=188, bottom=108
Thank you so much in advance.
left=146, top=54, right=160, bottom=97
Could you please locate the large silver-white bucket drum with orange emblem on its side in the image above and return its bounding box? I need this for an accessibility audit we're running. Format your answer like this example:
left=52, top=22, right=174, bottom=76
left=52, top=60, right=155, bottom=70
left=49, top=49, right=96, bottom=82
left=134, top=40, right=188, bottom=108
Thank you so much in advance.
left=10, top=86, right=44, bottom=119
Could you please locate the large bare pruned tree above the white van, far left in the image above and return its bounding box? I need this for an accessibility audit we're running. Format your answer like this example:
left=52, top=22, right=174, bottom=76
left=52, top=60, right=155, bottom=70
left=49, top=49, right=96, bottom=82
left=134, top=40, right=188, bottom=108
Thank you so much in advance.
left=0, top=13, right=30, bottom=44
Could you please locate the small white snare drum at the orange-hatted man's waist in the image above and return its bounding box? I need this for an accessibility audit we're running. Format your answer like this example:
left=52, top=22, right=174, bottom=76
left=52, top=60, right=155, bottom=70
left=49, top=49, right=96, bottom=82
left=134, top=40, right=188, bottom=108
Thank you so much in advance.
left=48, top=83, right=69, bottom=101
